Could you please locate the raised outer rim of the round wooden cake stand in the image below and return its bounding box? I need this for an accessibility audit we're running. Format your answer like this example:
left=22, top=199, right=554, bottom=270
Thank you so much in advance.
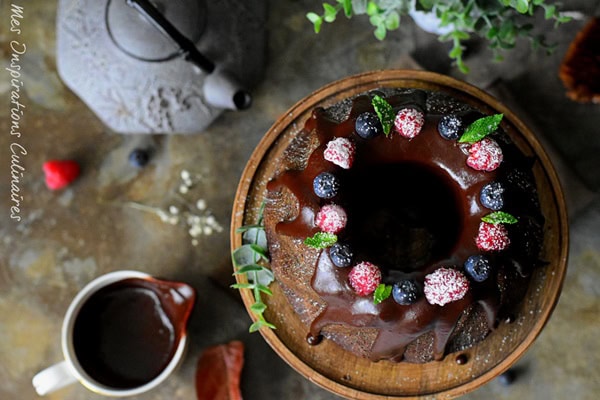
left=230, top=69, right=569, bottom=400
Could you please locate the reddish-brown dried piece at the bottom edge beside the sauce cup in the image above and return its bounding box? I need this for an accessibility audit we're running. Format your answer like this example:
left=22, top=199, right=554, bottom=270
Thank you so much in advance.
left=196, top=340, right=244, bottom=400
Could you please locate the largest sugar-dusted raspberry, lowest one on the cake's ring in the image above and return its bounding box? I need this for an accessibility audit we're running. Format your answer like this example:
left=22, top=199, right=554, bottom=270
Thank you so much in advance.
left=423, top=267, right=469, bottom=306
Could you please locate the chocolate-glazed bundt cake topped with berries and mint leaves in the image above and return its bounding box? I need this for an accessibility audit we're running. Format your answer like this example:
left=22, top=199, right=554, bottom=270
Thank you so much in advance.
left=264, top=88, right=544, bottom=363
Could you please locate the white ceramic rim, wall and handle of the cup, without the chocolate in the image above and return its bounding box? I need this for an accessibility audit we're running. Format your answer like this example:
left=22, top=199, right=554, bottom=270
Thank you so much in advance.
left=32, top=270, right=195, bottom=397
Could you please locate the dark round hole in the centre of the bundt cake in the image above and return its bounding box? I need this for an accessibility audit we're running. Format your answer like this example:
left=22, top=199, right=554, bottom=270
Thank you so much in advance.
left=344, top=163, right=462, bottom=273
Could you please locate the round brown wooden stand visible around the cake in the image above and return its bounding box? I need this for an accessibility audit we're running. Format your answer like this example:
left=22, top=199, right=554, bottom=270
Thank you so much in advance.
left=231, top=70, right=568, bottom=400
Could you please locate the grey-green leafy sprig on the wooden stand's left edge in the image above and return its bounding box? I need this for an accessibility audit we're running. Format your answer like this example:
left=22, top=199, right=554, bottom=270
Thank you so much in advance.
left=231, top=204, right=276, bottom=332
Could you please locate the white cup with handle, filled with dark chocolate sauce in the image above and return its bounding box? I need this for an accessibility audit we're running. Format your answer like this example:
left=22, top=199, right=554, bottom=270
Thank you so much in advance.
left=33, top=271, right=196, bottom=397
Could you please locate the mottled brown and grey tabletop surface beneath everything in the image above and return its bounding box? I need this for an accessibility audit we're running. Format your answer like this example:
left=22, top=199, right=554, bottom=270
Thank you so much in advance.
left=0, top=0, right=600, bottom=400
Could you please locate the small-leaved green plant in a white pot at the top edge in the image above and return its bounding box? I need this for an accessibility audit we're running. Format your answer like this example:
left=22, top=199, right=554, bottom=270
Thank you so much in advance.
left=306, top=0, right=570, bottom=73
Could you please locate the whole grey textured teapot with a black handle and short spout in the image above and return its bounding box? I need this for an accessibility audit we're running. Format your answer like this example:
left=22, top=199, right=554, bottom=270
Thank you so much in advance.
left=57, top=0, right=266, bottom=133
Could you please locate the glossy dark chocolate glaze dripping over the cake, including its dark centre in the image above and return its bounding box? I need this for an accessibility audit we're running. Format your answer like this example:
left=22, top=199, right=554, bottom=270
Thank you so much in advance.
left=267, top=91, right=543, bottom=361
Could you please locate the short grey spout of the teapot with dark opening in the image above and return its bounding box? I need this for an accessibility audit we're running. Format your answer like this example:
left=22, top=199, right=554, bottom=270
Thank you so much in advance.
left=203, top=70, right=252, bottom=111
